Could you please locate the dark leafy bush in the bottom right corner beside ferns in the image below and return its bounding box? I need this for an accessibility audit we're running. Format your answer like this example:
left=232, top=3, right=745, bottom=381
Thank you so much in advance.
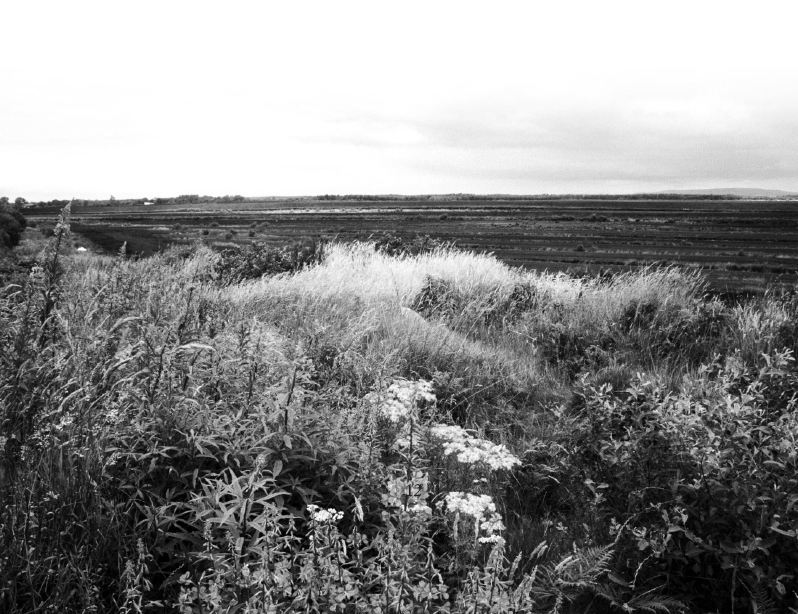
left=569, top=354, right=798, bottom=611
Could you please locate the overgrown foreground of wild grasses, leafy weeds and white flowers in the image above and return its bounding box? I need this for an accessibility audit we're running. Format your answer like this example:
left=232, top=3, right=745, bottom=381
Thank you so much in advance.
left=0, top=208, right=798, bottom=614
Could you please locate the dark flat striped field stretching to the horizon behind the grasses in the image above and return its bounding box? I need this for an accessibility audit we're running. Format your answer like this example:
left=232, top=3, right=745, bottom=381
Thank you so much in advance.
left=26, top=199, right=798, bottom=293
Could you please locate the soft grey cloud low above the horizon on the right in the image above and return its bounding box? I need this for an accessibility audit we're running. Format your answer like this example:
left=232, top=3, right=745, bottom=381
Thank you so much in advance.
left=378, top=98, right=798, bottom=190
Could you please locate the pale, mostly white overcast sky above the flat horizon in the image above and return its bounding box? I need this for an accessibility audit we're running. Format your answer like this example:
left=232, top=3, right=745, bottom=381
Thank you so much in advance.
left=0, top=0, right=798, bottom=200
